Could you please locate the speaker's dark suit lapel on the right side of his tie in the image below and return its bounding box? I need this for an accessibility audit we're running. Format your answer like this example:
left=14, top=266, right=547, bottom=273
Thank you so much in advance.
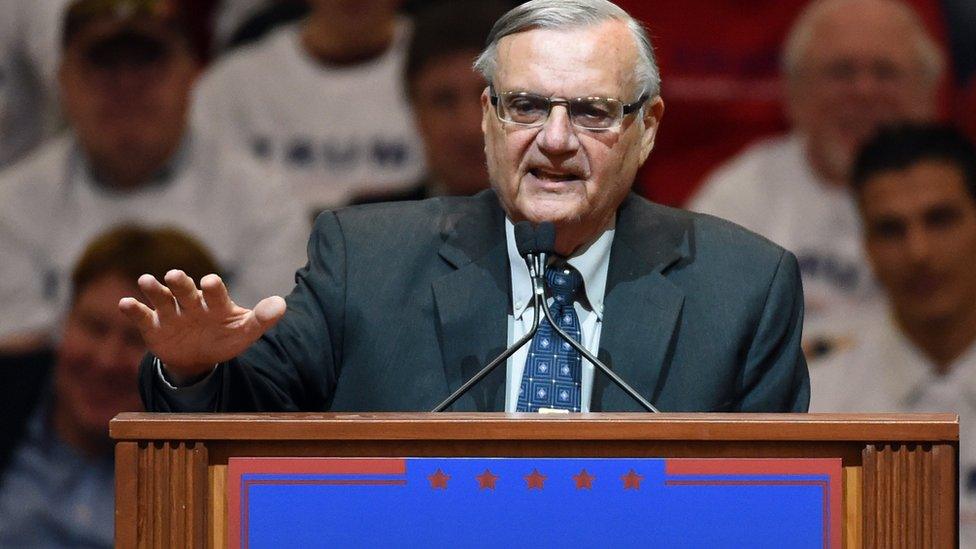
left=591, top=195, right=693, bottom=412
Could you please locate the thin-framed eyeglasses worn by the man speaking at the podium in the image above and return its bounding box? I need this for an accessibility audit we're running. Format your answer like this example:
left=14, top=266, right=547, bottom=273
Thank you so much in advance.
left=489, top=87, right=648, bottom=130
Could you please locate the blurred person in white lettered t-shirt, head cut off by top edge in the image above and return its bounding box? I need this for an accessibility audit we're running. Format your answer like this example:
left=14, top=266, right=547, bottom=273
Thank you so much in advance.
left=193, top=0, right=424, bottom=213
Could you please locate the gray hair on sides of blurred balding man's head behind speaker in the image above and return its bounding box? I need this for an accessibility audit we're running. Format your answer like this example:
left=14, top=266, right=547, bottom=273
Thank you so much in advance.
left=782, top=0, right=945, bottom=85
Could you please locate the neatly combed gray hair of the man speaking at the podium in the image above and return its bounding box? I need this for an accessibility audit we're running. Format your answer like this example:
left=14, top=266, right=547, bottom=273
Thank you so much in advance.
left=474, top=0, right=661, bottom=97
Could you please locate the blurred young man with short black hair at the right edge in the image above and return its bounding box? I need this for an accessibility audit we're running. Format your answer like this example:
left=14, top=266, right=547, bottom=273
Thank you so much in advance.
left=810, top=124, right=976, bottom=547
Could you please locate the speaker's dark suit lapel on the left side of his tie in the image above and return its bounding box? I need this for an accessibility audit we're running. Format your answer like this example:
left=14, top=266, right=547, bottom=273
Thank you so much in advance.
left=433, top=192, right=511, bottom=411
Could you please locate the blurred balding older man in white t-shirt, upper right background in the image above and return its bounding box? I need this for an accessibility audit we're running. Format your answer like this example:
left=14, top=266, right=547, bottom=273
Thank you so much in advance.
left=689, top=0, right=943, bottom=355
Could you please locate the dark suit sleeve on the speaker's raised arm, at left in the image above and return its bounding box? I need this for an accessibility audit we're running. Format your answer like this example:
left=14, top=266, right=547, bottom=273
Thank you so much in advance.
left=140, top=212, right=346, bottom=412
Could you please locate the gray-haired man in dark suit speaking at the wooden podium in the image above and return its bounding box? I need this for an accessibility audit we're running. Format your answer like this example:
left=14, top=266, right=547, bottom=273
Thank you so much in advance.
left=119, top=0, right=809, bottom=412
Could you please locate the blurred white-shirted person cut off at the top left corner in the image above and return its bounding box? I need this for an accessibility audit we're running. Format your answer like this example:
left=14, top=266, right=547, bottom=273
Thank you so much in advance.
left=0, top=0, right=67, bottom=168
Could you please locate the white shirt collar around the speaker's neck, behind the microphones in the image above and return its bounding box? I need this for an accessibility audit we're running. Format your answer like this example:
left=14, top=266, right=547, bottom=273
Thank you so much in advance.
left=505, top=216, right=616, bottom=321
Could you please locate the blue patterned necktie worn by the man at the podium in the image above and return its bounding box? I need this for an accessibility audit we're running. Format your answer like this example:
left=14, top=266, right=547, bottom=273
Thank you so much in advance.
left=516, top=266, right=583, bottom=412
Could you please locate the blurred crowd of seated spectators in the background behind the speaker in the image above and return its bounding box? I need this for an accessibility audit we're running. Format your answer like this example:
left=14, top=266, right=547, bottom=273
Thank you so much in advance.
left=0, top=0, right=976, bottom=547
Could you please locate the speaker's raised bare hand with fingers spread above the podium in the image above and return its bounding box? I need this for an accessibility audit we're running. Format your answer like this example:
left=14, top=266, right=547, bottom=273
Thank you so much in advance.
left=119, top=270, right=285, bottom=384
